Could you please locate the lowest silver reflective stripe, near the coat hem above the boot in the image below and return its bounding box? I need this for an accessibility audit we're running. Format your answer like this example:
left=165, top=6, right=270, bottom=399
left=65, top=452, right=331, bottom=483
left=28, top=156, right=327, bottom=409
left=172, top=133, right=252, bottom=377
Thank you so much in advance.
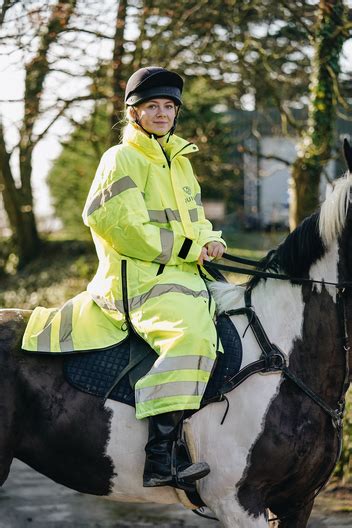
left=135, top=381, right=207, bottom=403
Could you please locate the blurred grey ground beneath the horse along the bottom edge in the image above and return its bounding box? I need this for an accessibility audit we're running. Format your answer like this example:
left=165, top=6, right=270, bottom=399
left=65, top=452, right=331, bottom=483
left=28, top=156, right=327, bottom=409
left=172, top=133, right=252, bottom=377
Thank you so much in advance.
left=0, top=461, right=352, bottom=528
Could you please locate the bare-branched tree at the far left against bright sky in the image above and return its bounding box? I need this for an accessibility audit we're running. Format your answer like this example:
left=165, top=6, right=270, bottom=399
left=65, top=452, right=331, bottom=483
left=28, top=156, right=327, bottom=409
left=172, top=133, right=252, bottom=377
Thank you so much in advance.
left=0, top=0, right=121, bottom=265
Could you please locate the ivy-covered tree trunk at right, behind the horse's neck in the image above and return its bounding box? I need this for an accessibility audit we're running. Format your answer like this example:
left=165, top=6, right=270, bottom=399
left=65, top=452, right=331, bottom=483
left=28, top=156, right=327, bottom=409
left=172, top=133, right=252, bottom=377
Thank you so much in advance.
left=290, top=0, right=347, bottom=230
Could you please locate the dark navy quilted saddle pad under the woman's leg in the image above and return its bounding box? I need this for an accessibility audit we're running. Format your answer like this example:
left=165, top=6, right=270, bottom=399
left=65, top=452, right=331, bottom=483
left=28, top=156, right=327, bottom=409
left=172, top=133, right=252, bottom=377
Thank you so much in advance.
left=64, top=314, right=242, bottom=407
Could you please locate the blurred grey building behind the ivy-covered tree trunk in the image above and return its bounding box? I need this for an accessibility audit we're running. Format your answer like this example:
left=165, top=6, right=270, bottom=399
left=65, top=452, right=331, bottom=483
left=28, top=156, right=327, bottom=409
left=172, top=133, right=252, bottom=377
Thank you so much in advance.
left=234, top=110, right=351, bottom=230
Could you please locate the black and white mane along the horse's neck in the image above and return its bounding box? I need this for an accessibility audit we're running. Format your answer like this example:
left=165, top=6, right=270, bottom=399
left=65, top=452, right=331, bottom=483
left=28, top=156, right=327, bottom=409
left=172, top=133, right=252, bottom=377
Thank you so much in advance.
left=211, top=172, right=352, bottom=311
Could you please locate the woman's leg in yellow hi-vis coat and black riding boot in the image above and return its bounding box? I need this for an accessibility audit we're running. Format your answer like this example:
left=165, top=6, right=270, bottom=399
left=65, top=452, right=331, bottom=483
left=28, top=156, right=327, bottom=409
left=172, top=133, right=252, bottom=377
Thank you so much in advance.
left=133, top=274, right=217, bottom=487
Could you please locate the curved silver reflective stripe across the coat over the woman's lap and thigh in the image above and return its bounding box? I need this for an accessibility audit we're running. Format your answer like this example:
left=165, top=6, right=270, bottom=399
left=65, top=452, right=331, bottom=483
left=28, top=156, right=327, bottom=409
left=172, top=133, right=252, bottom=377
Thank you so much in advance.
left=93, top=284, right=209, bottom=313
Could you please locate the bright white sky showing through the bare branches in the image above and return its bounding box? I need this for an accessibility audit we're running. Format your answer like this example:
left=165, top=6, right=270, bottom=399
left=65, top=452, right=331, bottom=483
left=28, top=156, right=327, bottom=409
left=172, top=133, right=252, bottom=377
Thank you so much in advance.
left=0, top=0, right=352, bottom=223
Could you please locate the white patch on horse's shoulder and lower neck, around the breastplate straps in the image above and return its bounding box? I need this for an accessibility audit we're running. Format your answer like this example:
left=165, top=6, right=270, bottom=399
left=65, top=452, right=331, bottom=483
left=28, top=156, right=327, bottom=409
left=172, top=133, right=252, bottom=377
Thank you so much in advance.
left=195, top=279, right=304, bottom=516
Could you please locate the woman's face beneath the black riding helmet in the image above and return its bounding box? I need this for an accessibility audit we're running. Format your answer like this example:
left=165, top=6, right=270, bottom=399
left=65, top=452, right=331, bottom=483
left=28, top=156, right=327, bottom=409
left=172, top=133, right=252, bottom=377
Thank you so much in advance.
left=136, top=98, right=176, bottom=136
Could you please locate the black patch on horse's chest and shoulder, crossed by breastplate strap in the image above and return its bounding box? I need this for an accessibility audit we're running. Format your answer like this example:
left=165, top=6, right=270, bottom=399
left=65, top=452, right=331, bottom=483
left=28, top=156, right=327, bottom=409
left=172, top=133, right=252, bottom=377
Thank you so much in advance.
left=237, top=285, right=345, bottom=526
